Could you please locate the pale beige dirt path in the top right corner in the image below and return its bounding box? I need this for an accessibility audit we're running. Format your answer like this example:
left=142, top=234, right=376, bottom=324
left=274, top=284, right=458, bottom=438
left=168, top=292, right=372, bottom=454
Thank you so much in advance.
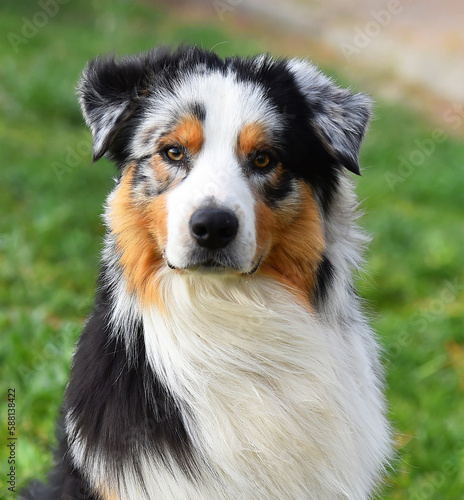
left=171, top=0, right=464, bottom=136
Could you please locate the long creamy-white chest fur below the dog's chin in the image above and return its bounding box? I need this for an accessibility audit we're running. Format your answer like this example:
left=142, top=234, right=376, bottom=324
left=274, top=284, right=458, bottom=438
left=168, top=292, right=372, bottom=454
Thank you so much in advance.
left=137, top=272, right=388, bottom=500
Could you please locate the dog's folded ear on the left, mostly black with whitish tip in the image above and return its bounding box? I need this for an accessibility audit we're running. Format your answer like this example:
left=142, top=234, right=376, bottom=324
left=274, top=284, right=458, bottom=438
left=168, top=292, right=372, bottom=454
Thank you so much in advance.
left=78, top=57, right=147, bottom=162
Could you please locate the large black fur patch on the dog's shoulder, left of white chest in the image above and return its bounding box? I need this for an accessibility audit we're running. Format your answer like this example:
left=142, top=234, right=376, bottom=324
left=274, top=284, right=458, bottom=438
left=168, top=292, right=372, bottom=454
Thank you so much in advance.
left=64, top=278, right=195, bottom=490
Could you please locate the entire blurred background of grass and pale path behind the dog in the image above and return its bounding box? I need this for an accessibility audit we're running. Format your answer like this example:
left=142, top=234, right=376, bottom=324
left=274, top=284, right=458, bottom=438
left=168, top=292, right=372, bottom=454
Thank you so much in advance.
left=0, top=0, right=464, bottom=500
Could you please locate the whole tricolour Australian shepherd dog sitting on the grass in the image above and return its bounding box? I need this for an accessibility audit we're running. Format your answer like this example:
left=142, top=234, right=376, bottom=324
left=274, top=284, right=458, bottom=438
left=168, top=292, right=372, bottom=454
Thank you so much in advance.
left=21, top=46, right=392, bottom=500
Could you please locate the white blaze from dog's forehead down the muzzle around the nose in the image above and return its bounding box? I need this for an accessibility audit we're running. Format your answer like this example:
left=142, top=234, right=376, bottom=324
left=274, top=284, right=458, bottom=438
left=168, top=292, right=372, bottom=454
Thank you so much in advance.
left=160, top=73, right=278, bottom=271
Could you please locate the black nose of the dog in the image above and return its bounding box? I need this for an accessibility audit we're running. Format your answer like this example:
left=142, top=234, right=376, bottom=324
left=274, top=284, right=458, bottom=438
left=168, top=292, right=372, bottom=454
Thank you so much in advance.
left=190, top=208, right=238, bottom=250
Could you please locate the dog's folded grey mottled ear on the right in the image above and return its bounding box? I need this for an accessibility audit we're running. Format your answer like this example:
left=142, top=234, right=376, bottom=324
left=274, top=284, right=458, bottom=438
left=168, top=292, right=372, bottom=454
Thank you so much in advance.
left=288, top=59, right=372, bottom=175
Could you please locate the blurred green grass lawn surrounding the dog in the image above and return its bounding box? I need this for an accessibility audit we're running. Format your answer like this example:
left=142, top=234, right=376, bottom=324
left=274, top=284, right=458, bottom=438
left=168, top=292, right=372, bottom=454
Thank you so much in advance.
left=0, top=0, right=464, bottom=500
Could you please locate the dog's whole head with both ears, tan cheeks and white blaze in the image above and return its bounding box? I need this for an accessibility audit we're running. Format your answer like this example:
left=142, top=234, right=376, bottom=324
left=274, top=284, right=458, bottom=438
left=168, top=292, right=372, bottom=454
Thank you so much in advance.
left=79, top=49, right=369, bottom=302
